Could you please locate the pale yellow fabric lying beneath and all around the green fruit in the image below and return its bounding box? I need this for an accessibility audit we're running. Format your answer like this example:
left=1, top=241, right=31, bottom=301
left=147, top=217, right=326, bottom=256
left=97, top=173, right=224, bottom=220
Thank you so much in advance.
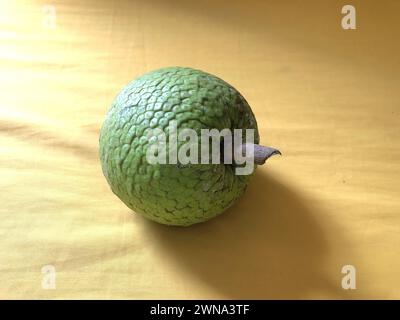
left=0, top=0, right=400, bottom=299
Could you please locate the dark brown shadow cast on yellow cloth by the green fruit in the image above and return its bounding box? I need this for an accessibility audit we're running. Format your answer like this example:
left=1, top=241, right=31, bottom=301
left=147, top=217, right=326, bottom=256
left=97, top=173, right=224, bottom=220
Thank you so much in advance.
left=145, top=170, right=342, bottom=299
